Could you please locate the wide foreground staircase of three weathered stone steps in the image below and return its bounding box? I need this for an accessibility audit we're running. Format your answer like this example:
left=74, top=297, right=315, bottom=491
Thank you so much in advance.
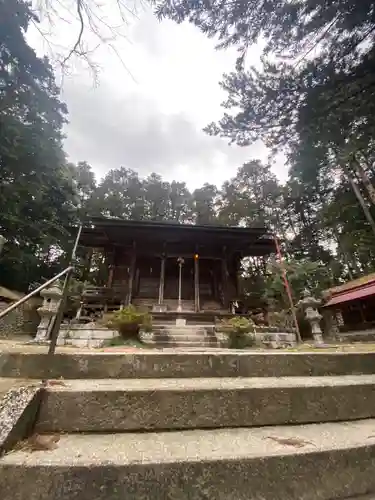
left=0, top=351, right=375, bottom=500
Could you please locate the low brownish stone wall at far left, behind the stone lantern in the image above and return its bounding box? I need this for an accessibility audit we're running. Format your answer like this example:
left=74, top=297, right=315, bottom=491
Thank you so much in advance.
left=0, top=299, right=40, bottom=338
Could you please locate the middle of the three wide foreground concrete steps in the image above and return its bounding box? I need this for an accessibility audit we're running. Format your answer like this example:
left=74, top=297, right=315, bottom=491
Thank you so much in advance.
left=37, top=375, right=375, bottom=432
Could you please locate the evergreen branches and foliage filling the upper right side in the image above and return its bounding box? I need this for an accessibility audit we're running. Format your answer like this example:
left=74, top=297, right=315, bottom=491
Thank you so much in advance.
left=154, top=0, right=375, bottom=280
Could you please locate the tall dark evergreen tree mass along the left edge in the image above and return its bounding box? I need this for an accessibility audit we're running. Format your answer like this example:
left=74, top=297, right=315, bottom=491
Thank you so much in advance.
left=0, top=0, right=74, bottom=289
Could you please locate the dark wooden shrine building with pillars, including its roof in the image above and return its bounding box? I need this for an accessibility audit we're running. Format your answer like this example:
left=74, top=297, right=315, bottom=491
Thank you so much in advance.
left=79, top=217, right=275, bottom=315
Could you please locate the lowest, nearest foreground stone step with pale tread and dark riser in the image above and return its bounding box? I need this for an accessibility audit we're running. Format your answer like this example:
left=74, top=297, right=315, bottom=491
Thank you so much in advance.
left=0, top=419, right=375, bottom=500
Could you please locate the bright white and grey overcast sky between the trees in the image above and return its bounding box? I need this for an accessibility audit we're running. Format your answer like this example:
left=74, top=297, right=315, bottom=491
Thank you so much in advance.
left=29, top=0, right=286, bottom=189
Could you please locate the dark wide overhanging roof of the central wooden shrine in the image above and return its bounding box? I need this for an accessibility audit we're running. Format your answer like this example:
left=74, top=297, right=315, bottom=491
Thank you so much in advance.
left=76, top=217, right=275, bottom=256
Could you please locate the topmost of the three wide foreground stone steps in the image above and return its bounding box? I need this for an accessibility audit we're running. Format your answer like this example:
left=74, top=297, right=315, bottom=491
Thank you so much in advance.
left=0, top=349, right=375, bottom=379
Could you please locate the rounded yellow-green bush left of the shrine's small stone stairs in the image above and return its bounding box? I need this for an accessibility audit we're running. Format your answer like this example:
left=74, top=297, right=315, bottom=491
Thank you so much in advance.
left=103, top=305, right=152, bottom=339
